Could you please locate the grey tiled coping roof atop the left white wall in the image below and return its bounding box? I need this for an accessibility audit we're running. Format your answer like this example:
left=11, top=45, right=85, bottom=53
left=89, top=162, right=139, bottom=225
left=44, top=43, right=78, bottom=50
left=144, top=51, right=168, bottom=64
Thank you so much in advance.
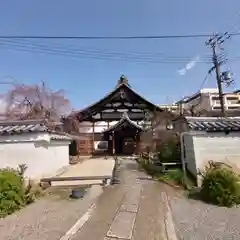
left=0, top=120, right=71, bottom=140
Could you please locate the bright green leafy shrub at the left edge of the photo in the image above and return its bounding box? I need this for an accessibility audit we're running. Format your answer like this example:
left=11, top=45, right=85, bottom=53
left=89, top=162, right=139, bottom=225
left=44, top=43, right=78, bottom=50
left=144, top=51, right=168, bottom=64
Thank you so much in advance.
left=0, top=168, right=25, bottom=217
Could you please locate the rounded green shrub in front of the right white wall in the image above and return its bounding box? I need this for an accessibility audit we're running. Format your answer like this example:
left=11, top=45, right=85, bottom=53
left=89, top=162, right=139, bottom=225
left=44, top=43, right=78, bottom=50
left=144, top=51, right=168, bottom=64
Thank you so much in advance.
left=200, top=163, right=240, bottom=207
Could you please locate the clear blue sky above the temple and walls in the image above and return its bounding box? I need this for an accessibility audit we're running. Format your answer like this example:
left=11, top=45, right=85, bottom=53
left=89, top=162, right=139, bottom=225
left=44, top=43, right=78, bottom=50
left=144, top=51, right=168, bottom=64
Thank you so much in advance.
left=0, top=0, right=240, bottom=108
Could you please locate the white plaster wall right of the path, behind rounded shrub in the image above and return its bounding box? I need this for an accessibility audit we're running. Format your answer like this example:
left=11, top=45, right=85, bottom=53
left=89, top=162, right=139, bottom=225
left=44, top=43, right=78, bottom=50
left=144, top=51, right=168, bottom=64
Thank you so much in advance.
left=186, top=133, right=240, bottom=186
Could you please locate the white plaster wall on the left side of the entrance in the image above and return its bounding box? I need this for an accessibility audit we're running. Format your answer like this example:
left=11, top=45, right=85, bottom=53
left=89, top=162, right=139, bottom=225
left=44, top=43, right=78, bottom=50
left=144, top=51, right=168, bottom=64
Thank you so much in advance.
left=0, top=134, right=70, bottom=179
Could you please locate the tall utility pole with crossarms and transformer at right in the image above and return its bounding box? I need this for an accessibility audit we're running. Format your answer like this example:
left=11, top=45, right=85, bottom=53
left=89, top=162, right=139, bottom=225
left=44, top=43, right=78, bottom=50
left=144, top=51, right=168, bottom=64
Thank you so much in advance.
left=206, top=32, right=230, bottom=117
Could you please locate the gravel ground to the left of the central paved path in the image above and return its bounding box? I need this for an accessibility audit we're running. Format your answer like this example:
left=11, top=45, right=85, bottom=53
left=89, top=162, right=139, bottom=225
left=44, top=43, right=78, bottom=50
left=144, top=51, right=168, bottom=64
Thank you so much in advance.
left=0, top=186, right=102, bottom=240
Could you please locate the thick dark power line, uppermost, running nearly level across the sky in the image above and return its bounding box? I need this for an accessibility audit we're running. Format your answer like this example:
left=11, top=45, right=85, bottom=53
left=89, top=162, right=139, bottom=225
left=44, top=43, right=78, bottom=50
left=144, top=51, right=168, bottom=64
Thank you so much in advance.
left=0, top=33, right=240, bottom=40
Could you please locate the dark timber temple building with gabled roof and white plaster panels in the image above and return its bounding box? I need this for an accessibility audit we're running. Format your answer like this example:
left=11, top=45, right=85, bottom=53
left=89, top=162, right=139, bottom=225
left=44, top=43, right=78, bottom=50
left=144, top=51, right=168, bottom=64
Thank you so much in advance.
left=68, top=75, right=163, bottom=155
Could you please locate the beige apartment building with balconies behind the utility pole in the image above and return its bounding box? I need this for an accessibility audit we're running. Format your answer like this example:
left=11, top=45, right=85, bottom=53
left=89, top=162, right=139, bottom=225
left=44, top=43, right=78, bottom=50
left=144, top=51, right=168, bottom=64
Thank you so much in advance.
left=176, top=88, right=240, bottom=111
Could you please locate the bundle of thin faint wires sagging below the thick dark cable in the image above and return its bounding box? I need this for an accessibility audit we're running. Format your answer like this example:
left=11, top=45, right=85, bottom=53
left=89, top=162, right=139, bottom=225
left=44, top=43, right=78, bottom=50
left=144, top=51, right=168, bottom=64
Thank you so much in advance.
left=0, top=39, right=240, bottom=64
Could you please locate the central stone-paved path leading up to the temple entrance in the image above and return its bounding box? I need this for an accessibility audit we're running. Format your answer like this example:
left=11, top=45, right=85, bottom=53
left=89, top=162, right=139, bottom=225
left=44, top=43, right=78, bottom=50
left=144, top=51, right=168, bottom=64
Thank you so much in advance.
left=72, top=160, right=171, bottom=240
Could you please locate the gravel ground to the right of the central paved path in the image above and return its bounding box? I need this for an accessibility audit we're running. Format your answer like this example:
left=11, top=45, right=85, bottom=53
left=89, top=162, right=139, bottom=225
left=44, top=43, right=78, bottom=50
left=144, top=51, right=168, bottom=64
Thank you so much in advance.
left=169, top=191, right=240, bottom=240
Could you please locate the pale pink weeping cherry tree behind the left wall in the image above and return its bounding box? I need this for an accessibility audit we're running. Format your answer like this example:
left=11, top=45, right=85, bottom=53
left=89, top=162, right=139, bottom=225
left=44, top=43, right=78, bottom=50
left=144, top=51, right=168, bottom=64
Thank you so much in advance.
left=0, top=81, right=78, bottom=132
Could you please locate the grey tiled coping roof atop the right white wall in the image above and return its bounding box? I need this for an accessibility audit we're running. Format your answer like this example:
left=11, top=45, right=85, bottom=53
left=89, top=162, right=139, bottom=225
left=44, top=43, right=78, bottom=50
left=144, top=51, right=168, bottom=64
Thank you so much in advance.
left=186, top=117, right=240, bottom=132
